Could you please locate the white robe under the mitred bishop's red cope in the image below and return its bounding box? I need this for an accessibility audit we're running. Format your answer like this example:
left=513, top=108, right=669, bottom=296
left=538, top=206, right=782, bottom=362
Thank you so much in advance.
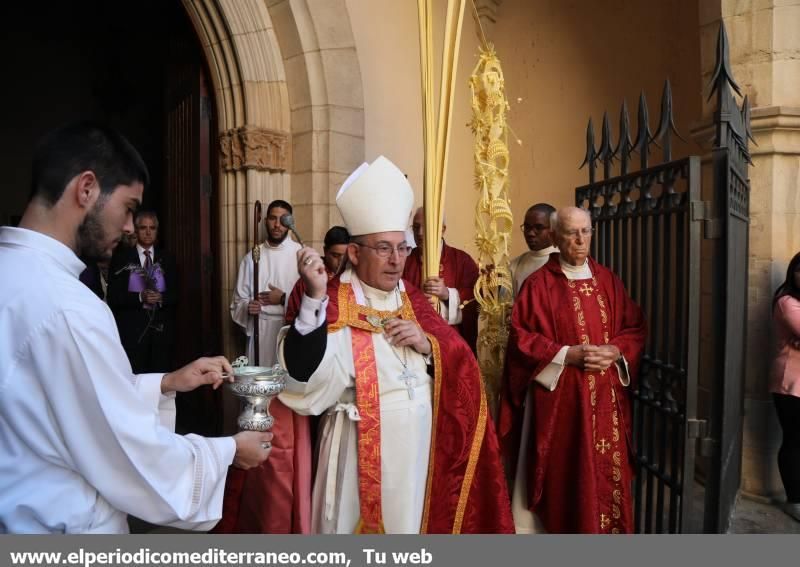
left=279, top=270, right=432, bottom=534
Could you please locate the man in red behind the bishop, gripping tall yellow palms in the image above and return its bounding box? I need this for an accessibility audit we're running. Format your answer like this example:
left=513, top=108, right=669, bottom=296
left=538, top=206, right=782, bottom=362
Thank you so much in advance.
left=403, top=207, right=478, bottom=352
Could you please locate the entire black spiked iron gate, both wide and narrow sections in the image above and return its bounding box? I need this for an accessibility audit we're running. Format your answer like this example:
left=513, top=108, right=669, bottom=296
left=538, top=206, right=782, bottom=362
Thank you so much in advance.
left=575, top=22, right=749, bottom=533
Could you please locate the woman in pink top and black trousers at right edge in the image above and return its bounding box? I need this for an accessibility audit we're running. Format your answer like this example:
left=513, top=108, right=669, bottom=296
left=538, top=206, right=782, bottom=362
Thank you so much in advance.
left=770, top=253, right=800, bottom=521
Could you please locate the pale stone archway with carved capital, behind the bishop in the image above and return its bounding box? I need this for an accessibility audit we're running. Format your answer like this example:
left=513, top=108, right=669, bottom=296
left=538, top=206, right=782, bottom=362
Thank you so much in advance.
left=182, top=0, right=364, bottom=355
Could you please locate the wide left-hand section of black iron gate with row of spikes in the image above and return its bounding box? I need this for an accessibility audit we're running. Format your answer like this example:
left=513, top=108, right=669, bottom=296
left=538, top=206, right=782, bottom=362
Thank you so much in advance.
left=576, top=83, right=700, bottom=533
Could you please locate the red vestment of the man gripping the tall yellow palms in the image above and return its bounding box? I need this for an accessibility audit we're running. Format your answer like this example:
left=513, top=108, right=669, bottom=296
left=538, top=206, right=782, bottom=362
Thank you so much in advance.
left=403, top=243, right=478, bottom=353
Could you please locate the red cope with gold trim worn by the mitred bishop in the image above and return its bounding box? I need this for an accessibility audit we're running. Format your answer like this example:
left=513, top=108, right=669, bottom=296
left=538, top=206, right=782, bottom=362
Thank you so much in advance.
left=287, top=277, right=514, bottom=533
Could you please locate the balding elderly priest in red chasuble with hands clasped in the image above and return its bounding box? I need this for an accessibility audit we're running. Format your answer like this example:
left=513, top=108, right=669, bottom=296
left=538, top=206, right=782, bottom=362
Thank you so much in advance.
left=499, top=207, right=646, bottom=533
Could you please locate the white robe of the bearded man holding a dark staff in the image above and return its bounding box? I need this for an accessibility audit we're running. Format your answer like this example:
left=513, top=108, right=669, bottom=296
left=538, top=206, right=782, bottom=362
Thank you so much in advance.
left=236, top=236, right=301, bottom=366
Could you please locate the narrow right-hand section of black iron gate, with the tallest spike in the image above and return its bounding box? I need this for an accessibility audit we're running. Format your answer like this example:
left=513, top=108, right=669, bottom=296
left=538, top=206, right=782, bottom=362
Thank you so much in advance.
left=704, top=22, right=752, bottom=532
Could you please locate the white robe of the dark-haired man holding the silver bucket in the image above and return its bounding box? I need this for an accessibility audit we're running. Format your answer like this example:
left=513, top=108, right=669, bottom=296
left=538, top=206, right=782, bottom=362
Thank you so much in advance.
left=0, top=227, right=236, bottom=533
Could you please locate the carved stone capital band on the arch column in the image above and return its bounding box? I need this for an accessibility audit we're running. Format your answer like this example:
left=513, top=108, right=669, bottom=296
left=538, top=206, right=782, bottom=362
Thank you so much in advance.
left=219, top=126, right=290, bottom=171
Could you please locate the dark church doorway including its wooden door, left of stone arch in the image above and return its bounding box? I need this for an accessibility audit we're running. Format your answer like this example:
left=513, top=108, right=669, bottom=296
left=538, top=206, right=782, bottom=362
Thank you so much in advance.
left=0, top=0, right=221, bottom=434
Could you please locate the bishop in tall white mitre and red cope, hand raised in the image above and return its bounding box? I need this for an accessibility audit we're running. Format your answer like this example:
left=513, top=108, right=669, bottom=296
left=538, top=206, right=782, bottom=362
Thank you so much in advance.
left=279, top=156, right=514, bottom=533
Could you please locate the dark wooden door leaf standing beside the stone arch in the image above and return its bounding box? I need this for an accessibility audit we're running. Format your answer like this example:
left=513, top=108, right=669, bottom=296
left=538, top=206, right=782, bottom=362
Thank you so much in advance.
left=162, top=7, right=221, bottom=435
